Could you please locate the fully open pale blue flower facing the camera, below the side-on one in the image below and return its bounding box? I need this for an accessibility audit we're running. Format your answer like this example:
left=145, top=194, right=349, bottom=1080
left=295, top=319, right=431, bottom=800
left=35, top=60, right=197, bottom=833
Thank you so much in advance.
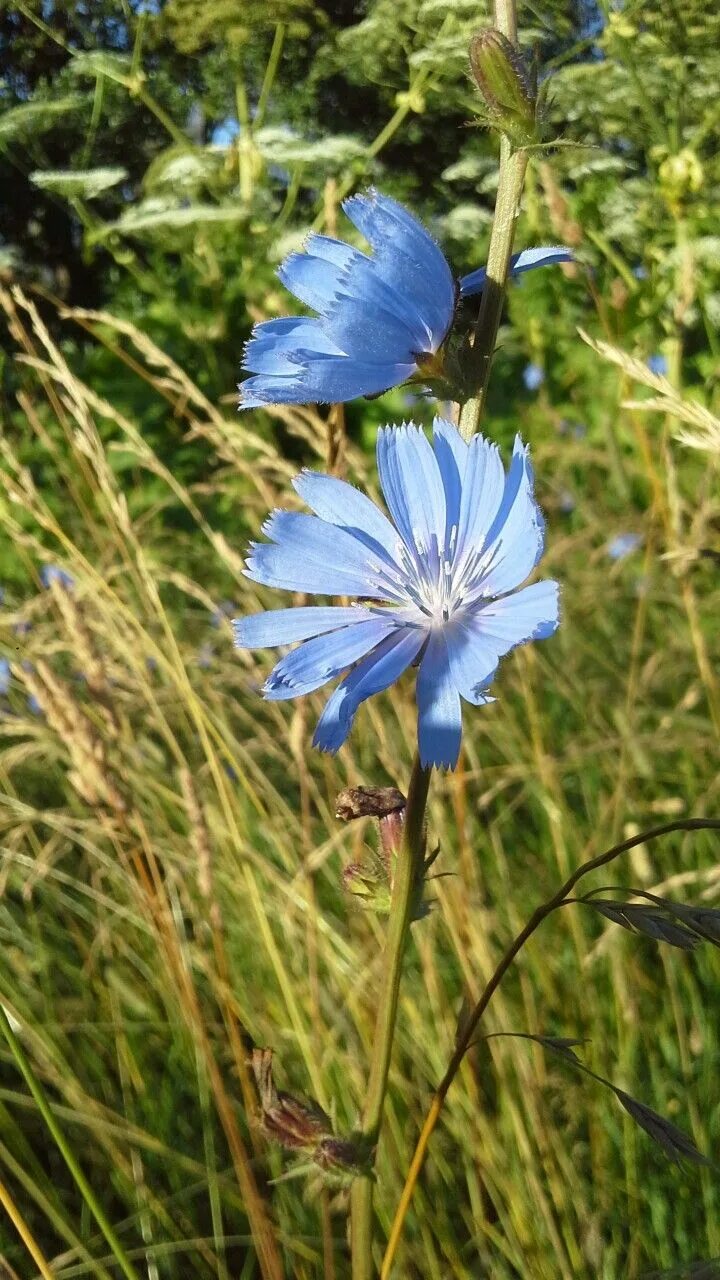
left=233, top=419, right=559, bottom=768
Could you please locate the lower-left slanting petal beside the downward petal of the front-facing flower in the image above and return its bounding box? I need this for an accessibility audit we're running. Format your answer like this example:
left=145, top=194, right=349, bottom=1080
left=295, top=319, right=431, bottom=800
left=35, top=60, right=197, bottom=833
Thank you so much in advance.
left=313, top=628, right=425, bottom=751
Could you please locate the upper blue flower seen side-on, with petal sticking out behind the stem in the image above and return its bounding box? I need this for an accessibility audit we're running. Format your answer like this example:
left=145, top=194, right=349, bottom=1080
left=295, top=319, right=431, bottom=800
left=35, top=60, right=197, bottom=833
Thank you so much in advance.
left=240, top=191, right=573, bottom=408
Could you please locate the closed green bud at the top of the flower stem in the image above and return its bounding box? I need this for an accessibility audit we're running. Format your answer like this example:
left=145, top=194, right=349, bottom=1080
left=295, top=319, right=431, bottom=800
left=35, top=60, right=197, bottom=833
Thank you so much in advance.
left=470, top=29, right=538, bottom=146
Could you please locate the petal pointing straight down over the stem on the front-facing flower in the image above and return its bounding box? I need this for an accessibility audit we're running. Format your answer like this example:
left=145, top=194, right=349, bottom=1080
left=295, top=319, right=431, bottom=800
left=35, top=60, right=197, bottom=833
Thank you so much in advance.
left=418, top=631, right=462, bottom=769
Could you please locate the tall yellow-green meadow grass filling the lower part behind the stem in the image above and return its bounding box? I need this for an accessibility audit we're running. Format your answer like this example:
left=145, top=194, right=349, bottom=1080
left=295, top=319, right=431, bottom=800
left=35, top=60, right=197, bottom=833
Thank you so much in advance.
left=0, top=282, right=720, bottom=1280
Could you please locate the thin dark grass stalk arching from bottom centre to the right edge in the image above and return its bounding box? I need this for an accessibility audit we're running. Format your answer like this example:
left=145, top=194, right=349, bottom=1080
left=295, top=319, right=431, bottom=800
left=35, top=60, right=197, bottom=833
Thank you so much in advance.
left=380, top=818, right=720, bottom=1280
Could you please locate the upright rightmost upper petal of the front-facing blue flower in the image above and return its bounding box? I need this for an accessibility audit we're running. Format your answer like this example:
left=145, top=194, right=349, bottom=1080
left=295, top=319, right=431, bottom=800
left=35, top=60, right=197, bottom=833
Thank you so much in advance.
left=482, top=436, right=544, bottom=595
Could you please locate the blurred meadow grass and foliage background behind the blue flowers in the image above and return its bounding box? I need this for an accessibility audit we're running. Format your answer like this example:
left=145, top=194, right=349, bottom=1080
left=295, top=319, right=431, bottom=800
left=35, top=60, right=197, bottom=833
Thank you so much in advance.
left=0, top=0, right=720, bottom=1280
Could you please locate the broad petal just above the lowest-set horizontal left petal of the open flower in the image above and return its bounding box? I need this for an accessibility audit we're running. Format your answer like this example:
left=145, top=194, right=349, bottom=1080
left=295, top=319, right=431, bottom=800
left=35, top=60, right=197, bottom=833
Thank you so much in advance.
left=246, top=511, right=397, bottom=600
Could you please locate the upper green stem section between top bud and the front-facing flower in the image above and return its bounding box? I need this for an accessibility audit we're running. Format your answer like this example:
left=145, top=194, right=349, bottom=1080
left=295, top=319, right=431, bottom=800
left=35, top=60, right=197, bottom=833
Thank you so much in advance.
left=459, top=138, right=528, bottom=440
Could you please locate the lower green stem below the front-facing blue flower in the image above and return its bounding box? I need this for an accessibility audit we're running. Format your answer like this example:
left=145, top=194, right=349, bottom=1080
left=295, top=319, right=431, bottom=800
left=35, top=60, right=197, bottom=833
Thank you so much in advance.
left=350, top=756, right=432, bottom=1280
